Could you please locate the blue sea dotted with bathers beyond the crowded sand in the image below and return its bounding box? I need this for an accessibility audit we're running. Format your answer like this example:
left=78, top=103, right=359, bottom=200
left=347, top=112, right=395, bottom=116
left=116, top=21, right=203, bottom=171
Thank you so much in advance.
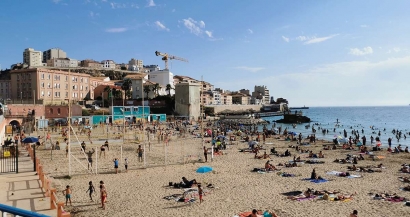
left=260, top=106, right=410, bottom=147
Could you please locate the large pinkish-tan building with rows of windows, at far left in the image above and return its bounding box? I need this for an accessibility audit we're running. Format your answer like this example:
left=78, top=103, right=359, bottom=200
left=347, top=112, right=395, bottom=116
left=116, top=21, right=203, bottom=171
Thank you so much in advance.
left=10, top=68, right=90, bottom=104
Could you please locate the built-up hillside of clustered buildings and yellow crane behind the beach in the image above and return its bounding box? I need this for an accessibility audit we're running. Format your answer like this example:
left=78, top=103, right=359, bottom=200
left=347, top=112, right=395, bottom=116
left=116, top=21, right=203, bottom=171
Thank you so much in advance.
left=0, top=48, right=287, bottom=124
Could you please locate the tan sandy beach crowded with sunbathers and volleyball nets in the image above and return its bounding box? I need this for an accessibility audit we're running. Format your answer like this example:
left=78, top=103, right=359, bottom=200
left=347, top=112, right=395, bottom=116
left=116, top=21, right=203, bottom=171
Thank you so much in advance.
left=37, top=124, right=410, bottom=217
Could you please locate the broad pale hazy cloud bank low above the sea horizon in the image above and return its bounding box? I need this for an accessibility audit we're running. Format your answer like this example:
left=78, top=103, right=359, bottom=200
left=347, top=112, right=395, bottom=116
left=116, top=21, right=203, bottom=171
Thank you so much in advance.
left=219, top=56, right=410, bottom=107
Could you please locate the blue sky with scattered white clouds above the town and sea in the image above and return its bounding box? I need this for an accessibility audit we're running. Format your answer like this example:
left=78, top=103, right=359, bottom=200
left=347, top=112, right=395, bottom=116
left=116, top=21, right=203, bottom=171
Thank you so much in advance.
left=0, top=0, right=410, bottom=106
